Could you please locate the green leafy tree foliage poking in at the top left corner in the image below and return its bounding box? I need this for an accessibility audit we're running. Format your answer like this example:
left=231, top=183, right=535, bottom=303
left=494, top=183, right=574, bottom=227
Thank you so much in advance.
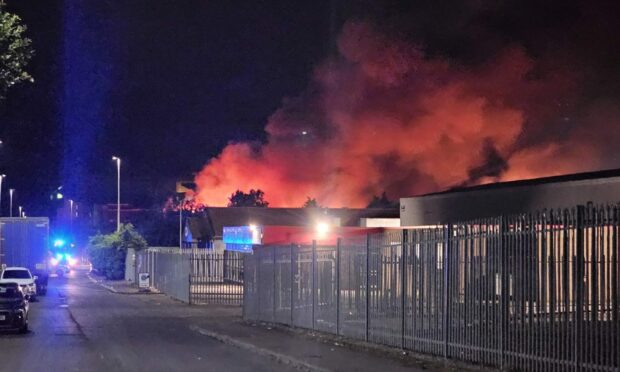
left=0, top=4, right=34, bottom=99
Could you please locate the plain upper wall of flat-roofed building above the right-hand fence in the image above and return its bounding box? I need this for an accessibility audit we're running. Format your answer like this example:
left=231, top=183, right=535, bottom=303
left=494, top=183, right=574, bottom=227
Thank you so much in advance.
left=400, top=177, right=620, bottom=226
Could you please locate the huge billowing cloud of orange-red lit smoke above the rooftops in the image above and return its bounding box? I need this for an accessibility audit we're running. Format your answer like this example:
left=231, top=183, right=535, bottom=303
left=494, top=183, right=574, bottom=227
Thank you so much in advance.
left=196, top=22, right=620, bottom=207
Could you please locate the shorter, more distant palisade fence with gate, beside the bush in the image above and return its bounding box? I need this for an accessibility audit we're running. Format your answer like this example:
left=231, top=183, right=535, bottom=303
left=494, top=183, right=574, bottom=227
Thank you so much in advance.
left=136, top=247, right=243, bottom=305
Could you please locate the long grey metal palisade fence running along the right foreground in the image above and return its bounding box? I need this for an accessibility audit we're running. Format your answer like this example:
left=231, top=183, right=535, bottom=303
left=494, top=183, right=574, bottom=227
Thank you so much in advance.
left=244, top=206, right=620, bottom=371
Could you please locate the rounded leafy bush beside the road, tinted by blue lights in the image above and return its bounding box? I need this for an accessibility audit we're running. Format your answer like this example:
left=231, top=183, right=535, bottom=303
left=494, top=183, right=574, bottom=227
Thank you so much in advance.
left=88, top=224, right=147, bottom=280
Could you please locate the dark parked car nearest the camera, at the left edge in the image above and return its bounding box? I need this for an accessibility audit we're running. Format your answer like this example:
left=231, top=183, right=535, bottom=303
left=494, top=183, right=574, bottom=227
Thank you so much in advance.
left=0, top=283, right=29, bottom=333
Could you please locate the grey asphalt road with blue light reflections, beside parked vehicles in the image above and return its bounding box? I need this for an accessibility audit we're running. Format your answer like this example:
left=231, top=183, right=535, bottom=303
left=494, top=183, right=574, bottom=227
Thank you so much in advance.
left=0, top=272, right=296, bottom=372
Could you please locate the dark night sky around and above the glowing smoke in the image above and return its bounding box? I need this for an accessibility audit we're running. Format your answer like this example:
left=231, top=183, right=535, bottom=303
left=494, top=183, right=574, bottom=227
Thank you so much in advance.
left=0, top=0, right=620, bottom=215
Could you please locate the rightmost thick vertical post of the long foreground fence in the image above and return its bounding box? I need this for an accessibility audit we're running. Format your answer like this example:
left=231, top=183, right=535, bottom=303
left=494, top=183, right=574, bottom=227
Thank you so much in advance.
left=573, top=205, right=586, bottom=371
